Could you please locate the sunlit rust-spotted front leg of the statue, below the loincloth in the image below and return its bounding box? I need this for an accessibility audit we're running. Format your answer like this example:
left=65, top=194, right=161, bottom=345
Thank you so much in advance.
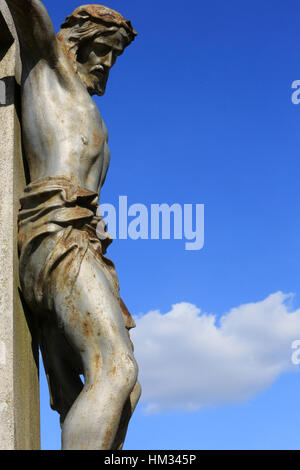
left=54, top=250, right=138, bottom=450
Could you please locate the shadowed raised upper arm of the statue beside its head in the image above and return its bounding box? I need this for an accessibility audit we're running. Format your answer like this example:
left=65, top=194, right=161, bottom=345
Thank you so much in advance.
left=6, top=0, right=58, bottom=66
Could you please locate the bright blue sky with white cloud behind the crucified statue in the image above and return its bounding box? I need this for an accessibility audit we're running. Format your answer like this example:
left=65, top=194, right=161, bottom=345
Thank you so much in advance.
left=41, top=0, right=300, bottom=449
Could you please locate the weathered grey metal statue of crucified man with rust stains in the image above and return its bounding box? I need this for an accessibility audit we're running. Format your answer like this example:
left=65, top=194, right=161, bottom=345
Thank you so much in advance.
left=6, top=0, right=140, bottom=450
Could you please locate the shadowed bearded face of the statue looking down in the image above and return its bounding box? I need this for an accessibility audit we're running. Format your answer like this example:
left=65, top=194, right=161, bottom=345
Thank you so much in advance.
left=77, top=31, right=126, bottom=96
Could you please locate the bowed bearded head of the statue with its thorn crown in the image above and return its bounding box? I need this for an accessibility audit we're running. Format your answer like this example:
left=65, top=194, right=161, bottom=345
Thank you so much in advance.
left=57, top=5, right=137, bottom=96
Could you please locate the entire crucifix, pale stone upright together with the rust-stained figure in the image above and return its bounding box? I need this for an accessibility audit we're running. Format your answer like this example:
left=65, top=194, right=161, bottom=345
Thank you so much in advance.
left=0, top=0, right=141, bottom=450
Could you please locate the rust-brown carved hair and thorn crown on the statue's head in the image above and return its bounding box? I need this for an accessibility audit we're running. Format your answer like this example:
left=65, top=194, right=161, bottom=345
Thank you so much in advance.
left=57, top=5, right=137, bottom=56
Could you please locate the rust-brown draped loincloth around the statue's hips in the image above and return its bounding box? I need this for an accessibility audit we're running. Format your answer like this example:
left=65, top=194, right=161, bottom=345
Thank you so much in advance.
left=18, top=176, right=135, bottom=329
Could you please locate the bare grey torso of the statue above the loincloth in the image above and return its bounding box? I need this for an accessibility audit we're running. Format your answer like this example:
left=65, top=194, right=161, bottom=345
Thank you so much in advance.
left=22, top=46, right=110, bottom=192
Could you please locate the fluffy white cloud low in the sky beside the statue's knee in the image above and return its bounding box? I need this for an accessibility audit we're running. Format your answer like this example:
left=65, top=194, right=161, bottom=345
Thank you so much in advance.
left=132, top=292, right=300, bottom=411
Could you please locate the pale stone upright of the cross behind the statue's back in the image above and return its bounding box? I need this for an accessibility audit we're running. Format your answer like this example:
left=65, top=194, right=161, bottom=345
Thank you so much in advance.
left=0, top=0, right=40, bottom=450
